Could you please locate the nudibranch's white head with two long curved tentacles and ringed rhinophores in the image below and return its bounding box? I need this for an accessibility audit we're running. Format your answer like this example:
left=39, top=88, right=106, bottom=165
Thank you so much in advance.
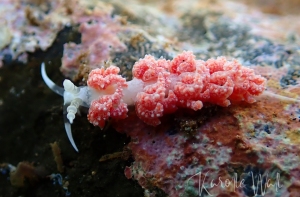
left=41, top=63, right=89, bottom=152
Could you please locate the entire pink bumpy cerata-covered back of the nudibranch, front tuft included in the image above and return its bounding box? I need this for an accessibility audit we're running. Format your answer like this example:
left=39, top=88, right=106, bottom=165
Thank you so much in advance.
left=87, top=51, right=265, bottom=128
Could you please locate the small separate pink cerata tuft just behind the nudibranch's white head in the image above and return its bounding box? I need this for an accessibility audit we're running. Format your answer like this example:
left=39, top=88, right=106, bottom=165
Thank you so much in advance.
left=87, top=66, right=128, bottom=128
